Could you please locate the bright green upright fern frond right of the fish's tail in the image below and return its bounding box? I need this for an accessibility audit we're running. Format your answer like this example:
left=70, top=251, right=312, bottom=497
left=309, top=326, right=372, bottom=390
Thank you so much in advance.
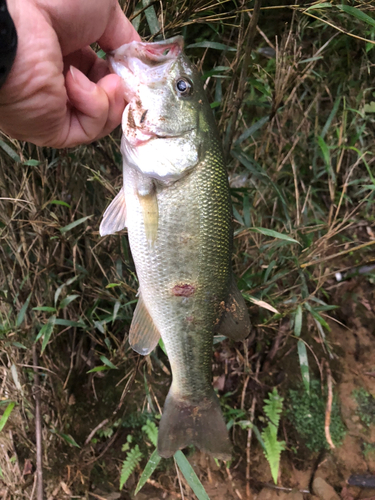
left=262, top=388, right=285, bottom=484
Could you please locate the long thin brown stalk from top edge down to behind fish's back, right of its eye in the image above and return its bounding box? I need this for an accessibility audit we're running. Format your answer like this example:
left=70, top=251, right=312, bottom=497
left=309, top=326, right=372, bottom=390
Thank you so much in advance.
left=224, top=0, right=262, bottom=158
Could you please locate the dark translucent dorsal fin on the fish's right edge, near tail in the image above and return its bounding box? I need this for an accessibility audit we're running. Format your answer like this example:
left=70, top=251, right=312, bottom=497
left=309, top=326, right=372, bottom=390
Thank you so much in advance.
left=215, top=276, right=251, bottom=340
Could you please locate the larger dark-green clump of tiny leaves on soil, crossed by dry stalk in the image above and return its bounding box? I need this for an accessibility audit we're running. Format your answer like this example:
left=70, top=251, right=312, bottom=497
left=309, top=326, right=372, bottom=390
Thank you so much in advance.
left=286, top=380, right=346, bottom=452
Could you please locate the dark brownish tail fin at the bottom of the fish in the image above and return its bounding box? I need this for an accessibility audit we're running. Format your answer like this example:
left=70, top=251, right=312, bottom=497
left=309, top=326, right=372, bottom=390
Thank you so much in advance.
left=158, top=388, right=231, bottom=460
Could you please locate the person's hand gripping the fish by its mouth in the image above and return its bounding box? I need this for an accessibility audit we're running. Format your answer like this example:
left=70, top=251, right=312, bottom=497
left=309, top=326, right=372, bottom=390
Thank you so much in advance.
left=0, top=0, right=140, bottom=148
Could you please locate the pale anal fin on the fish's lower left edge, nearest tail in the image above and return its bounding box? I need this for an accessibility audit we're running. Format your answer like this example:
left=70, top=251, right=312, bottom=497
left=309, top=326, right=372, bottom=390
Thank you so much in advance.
left=129, top=295, right=160, bottom=356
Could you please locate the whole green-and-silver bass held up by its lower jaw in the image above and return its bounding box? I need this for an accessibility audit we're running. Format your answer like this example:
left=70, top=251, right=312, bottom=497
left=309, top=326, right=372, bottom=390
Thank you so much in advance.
left=100, top=36, right=250, bottom=460
